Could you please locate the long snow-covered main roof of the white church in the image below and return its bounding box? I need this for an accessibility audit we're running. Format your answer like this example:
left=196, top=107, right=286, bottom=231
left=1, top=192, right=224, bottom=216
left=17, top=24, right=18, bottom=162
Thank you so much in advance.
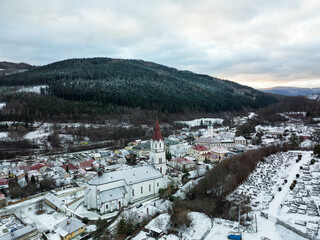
left=88, top=165, right=162, bottom=185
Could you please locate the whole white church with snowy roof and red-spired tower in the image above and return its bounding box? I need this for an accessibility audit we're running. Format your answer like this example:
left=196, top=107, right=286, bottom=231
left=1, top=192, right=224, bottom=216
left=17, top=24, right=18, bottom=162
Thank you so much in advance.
left=84, top=120, right=168, bottom=214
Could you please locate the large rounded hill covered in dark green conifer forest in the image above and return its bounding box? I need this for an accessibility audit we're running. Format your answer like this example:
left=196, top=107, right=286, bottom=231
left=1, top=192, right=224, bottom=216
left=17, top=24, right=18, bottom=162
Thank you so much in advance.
left=0, top=58, right=277, bottom=113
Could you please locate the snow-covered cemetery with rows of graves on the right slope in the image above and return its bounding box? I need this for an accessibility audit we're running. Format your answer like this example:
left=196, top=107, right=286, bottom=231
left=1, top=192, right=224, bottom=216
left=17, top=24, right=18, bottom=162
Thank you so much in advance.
left=229, top=151, right=320, bottom=239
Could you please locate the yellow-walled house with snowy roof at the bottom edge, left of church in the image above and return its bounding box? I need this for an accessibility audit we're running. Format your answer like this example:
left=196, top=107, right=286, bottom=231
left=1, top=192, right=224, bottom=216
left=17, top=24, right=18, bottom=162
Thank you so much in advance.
left=54, top=218, right=86, bottom=240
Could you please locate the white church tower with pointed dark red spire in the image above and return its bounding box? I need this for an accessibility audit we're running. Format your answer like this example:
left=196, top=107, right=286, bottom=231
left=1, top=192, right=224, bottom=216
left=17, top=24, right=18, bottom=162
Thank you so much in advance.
left=149, top=119, right=167, bottom=175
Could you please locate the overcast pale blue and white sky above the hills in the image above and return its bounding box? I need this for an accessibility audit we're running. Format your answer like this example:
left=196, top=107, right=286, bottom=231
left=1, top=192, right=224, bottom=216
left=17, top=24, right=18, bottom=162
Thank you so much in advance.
left=0, top=0, right=320, bottom=88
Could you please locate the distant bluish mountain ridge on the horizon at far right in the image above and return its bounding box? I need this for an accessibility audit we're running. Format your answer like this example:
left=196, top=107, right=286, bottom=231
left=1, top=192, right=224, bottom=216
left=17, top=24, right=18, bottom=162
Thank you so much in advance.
left=260, top=87, right=320, bottom=96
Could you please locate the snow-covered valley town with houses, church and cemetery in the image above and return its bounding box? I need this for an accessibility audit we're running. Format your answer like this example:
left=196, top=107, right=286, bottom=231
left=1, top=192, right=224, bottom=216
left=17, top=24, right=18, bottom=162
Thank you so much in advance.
left=0, top=113, right=320, bottom=240
